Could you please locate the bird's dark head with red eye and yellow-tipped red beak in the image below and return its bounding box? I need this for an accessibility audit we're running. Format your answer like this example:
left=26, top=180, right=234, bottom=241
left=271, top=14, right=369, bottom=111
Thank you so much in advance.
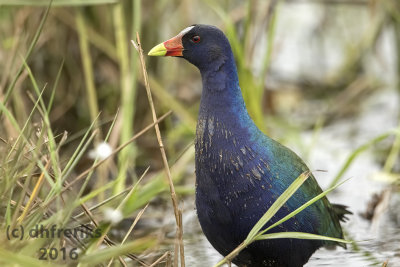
left=148, top=24, right=232, bottom=70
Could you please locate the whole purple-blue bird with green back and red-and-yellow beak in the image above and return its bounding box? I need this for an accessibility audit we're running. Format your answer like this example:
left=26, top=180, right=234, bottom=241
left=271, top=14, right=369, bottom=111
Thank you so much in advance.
left=149, top=25, right=343, bottom=267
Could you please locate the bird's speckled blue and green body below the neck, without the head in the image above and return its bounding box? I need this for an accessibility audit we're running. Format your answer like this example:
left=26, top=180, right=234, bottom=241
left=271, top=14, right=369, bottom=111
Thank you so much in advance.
left=196, top=113, right=343, bottom=266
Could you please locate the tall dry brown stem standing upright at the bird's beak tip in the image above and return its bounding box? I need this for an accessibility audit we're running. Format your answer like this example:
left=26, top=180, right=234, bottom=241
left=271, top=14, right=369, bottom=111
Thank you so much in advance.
left=132, top=35, right=185, bottom=267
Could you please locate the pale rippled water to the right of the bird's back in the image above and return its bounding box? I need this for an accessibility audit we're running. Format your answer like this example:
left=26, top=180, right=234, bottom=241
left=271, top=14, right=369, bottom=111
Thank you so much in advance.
left=306, top=90, right=400, bottom=267
